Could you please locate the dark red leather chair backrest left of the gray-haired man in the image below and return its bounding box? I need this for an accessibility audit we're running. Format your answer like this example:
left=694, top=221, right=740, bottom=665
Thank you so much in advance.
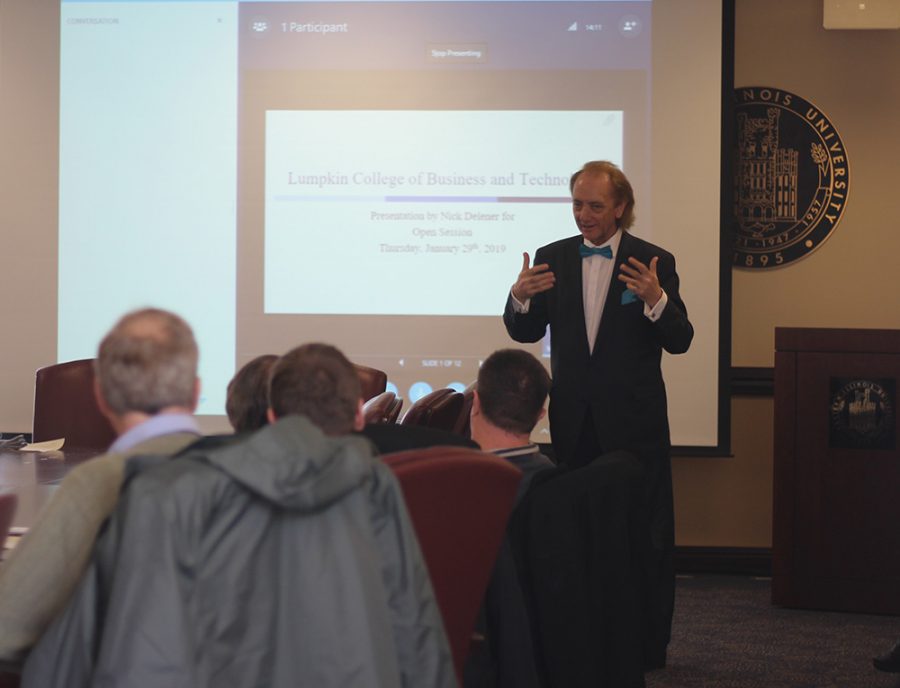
left=32, top=358, right=116, bottom=451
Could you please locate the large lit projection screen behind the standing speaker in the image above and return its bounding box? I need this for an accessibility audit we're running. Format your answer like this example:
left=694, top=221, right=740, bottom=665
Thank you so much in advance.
left=0, top=0, right=728, bottom=448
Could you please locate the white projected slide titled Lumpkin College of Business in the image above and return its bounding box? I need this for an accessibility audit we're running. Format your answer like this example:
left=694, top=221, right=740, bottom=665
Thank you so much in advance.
left=265, top=110, right=623, bottom=316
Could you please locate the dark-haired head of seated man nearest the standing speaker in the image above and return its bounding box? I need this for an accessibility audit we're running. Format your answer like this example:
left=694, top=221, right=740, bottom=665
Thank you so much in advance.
left=471, top=349, right=550, bottom=449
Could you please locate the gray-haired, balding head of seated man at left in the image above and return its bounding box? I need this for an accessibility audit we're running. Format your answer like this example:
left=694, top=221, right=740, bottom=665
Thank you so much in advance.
left=95, top=308, right=200, bottom=433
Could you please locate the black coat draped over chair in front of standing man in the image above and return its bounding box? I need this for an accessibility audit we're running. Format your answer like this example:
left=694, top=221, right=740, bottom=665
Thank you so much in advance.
left=507, top=452, right=649, bottom=688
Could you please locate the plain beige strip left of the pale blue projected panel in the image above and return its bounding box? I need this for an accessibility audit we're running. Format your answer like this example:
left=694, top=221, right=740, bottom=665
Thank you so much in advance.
left=0, top=0, right=59, bottom=432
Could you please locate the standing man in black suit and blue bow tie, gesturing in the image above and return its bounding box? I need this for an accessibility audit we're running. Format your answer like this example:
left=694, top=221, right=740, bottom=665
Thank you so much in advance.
left=503, top=161, right=694, bottom=668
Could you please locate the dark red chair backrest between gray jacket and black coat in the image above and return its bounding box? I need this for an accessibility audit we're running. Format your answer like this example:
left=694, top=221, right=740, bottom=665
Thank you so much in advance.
left=383, top=447, right=522, bottom=677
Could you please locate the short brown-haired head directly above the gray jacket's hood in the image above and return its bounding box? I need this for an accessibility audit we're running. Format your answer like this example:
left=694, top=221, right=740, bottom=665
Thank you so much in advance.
left=269, top=344, right=364, bottom=435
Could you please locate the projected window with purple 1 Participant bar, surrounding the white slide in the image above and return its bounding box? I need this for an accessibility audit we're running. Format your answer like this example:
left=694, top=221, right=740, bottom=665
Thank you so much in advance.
left=237, top=2, right=651, bottom=430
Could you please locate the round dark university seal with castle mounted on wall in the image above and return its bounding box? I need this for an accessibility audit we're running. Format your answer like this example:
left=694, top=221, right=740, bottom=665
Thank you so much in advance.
left=733, top=86, right=850, bottom=268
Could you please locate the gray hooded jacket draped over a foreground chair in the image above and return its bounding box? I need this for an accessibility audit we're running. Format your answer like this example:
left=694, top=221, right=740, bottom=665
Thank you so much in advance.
left=22, top=416, right=456, bottom=688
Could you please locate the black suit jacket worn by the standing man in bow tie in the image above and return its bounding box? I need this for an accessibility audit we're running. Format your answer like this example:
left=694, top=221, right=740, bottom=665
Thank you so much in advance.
left=503, top=232, right=694, bottom=460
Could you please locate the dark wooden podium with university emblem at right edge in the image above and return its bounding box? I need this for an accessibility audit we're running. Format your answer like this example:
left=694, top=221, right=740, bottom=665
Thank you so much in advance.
left=772, top=328, right=900, bottom=614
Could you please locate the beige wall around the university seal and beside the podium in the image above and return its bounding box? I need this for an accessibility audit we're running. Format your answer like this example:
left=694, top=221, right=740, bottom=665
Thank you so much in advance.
left=674, top=0, right=900, bottom=547
